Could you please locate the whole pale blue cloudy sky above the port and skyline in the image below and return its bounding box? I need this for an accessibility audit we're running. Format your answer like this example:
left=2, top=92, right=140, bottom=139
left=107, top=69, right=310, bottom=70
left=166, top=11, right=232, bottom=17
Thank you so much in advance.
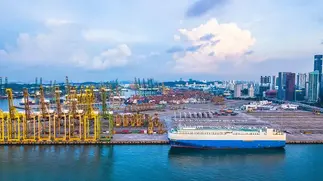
left=0, top=0, right=323, bottom=82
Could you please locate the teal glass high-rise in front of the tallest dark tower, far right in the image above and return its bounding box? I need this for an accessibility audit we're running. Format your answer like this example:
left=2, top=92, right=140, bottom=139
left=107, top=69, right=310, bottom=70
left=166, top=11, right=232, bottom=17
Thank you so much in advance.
left=308, top=70, right=320, bottom=102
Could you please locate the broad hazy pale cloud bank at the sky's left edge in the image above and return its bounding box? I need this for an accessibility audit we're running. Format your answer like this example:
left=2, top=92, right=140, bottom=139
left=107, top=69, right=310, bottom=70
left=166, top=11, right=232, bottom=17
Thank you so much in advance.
left=0, top=20, right=132, bottom=70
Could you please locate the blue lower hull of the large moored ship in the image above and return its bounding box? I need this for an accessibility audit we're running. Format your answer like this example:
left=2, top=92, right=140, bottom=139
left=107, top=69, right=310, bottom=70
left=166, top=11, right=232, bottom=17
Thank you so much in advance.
left=170, top=140, right=286, bottom=149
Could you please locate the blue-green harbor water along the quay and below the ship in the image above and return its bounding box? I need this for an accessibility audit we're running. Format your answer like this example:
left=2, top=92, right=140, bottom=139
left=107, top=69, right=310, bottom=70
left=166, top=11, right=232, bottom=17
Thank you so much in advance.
left=0, top=145, right=323, bottom=181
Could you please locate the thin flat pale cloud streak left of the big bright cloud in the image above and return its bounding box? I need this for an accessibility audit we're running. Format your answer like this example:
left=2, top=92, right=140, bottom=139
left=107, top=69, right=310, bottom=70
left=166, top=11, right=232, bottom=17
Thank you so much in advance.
left=82, top=29, right=147, bottom=43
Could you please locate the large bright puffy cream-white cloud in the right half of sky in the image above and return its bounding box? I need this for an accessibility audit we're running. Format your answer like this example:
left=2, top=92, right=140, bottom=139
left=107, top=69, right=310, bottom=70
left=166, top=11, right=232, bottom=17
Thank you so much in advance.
left=173, top=19, right=259, bottom=73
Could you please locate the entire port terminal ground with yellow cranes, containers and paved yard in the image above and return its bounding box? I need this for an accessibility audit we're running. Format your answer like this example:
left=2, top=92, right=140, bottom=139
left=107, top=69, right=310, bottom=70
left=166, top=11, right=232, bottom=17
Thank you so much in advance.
left=0, top=76, right=323, bottom=144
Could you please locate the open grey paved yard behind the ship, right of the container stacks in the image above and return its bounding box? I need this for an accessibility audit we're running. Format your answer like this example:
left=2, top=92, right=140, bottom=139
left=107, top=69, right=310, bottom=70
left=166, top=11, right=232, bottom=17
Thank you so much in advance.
left=172, top=100, right=323, bottom=143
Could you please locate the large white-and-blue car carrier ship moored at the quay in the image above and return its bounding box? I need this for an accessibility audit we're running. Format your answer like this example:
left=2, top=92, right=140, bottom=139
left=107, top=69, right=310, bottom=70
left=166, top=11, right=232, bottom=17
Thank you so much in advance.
left=168, top=127, right=286, bottom=149
